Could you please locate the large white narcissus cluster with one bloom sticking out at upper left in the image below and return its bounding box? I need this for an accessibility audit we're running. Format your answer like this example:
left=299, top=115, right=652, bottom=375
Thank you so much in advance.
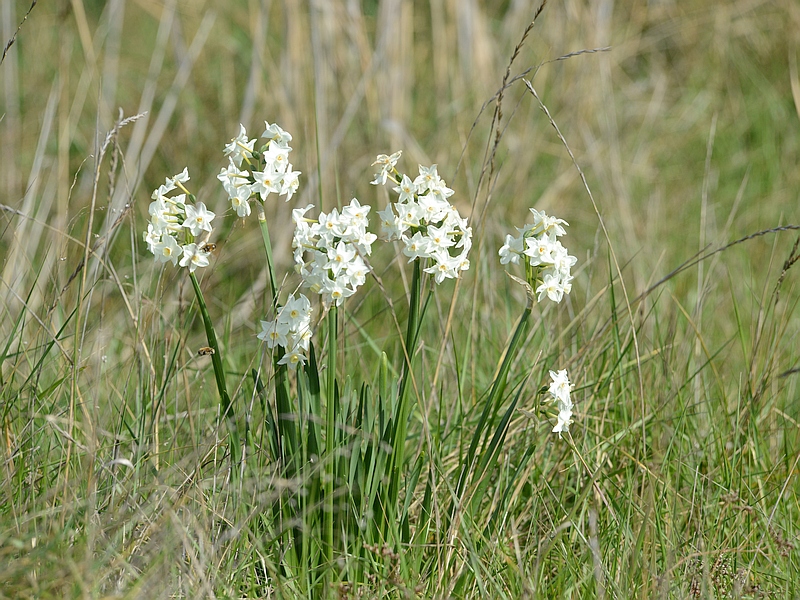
left=372, top=152, right=472, bottom=283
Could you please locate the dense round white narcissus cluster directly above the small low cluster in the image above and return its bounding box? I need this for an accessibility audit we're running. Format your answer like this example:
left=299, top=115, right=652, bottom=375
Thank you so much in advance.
left=292, top=198, right=377, bottom=307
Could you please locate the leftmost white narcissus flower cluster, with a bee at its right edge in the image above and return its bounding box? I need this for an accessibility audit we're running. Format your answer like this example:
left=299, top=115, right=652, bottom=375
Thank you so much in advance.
left=144, top=169, right=216, bottom=273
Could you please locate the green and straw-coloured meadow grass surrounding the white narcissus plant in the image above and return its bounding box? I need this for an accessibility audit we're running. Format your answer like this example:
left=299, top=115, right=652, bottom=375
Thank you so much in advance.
left=0, top=0, right=800, bottom=598
